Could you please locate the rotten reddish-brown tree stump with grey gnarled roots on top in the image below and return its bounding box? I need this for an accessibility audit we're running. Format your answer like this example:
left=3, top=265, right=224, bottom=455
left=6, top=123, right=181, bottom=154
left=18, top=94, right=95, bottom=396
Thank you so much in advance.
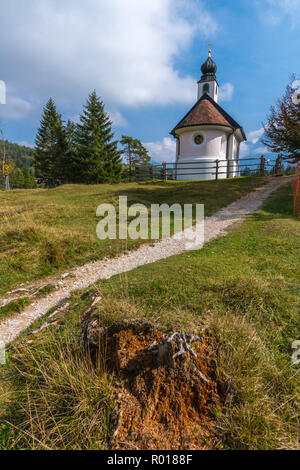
left=82, top=308, right=223, bottom=449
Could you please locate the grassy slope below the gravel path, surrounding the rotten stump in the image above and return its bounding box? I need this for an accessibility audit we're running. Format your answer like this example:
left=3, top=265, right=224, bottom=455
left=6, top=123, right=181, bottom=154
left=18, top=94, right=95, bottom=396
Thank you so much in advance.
left=0, top=182, right=300, bottom=450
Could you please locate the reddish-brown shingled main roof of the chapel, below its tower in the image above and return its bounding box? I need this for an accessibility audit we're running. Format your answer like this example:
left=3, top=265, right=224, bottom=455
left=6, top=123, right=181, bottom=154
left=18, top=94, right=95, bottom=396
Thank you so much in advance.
left=171, top=93, right=246, bottom=140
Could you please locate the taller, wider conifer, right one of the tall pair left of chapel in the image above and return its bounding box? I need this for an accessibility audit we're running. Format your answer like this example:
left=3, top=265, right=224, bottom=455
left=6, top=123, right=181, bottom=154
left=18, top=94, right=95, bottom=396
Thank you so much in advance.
left=75, top=91, right=122, bottom=184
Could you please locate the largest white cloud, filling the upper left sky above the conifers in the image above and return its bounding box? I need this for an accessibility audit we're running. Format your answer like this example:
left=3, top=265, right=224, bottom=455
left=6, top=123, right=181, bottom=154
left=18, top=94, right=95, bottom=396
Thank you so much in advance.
left=0, top=0, right=218, bottom=113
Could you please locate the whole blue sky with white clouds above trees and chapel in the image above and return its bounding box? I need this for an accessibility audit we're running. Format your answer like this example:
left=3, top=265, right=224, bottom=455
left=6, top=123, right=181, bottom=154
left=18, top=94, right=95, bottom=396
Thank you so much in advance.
left=0, top=0, right=300, bottom=161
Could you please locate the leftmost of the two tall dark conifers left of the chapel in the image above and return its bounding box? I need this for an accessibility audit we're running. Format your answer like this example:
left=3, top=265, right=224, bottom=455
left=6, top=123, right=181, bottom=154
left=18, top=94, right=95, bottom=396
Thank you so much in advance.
left=34, top=98, right=68, bottom=187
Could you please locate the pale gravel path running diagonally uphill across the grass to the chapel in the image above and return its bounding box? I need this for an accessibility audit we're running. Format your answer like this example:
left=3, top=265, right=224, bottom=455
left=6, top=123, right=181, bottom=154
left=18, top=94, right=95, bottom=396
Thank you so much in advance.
left=0, top=178, right=291, bottom=344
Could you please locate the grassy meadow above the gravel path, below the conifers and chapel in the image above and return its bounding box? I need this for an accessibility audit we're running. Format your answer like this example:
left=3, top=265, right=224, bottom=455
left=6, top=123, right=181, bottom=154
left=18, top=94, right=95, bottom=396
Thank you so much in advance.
left=0, top=177, right=266, bottom=295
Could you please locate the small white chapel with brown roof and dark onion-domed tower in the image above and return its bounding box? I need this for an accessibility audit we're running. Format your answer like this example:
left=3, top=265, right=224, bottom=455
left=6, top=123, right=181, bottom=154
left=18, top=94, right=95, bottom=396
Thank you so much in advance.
left=171, top=49, right=247, bottom=180
